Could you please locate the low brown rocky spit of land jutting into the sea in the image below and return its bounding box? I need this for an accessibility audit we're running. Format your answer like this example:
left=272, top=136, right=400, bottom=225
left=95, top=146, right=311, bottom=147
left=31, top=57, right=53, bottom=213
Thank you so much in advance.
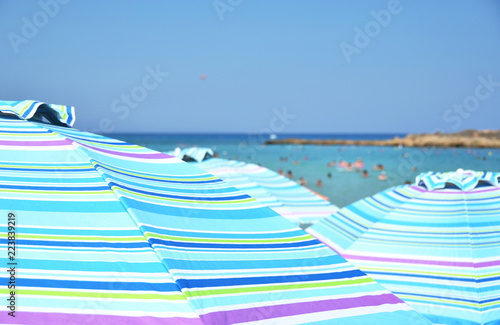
left=266, top=130, right=500, bottom=148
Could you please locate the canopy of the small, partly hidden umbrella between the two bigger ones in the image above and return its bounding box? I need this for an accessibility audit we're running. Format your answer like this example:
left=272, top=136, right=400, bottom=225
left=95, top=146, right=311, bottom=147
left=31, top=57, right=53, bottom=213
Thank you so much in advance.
left=197, top=158, right=338, bottom=224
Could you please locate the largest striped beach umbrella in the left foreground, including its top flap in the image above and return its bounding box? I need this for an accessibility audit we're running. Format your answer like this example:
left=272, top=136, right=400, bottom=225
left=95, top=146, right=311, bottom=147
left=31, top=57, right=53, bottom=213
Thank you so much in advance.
left=0, top=101, right=428, bottom=324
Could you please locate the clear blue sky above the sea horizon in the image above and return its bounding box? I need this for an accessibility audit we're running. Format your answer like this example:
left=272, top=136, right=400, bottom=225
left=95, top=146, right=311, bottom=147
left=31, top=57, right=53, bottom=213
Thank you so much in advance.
left=0, top=0, right=500, bottom=133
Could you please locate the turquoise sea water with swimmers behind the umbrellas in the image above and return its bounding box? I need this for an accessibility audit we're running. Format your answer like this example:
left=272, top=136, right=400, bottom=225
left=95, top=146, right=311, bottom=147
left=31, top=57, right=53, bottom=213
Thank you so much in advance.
left=109, top=134, right=500, bottom=207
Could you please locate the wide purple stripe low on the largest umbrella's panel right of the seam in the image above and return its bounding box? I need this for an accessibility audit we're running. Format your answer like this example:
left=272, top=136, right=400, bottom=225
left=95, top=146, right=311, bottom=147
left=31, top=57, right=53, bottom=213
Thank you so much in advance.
left=200, top=293, right=403, bottom=324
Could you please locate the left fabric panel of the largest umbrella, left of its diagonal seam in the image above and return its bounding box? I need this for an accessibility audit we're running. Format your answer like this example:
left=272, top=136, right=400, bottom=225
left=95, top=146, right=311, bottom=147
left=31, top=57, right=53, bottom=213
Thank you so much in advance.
left=0, top=110, right=202, bottom=324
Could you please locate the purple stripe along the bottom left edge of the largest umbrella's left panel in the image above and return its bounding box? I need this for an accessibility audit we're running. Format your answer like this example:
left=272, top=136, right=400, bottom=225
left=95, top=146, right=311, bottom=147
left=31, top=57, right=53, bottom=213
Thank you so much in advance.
left=0, top=308, right=203, bottom=325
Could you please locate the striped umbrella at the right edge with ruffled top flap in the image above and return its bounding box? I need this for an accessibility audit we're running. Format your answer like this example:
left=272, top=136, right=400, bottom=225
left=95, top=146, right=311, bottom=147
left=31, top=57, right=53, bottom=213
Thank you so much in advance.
left=308, top=170, right=500, bottom=324
